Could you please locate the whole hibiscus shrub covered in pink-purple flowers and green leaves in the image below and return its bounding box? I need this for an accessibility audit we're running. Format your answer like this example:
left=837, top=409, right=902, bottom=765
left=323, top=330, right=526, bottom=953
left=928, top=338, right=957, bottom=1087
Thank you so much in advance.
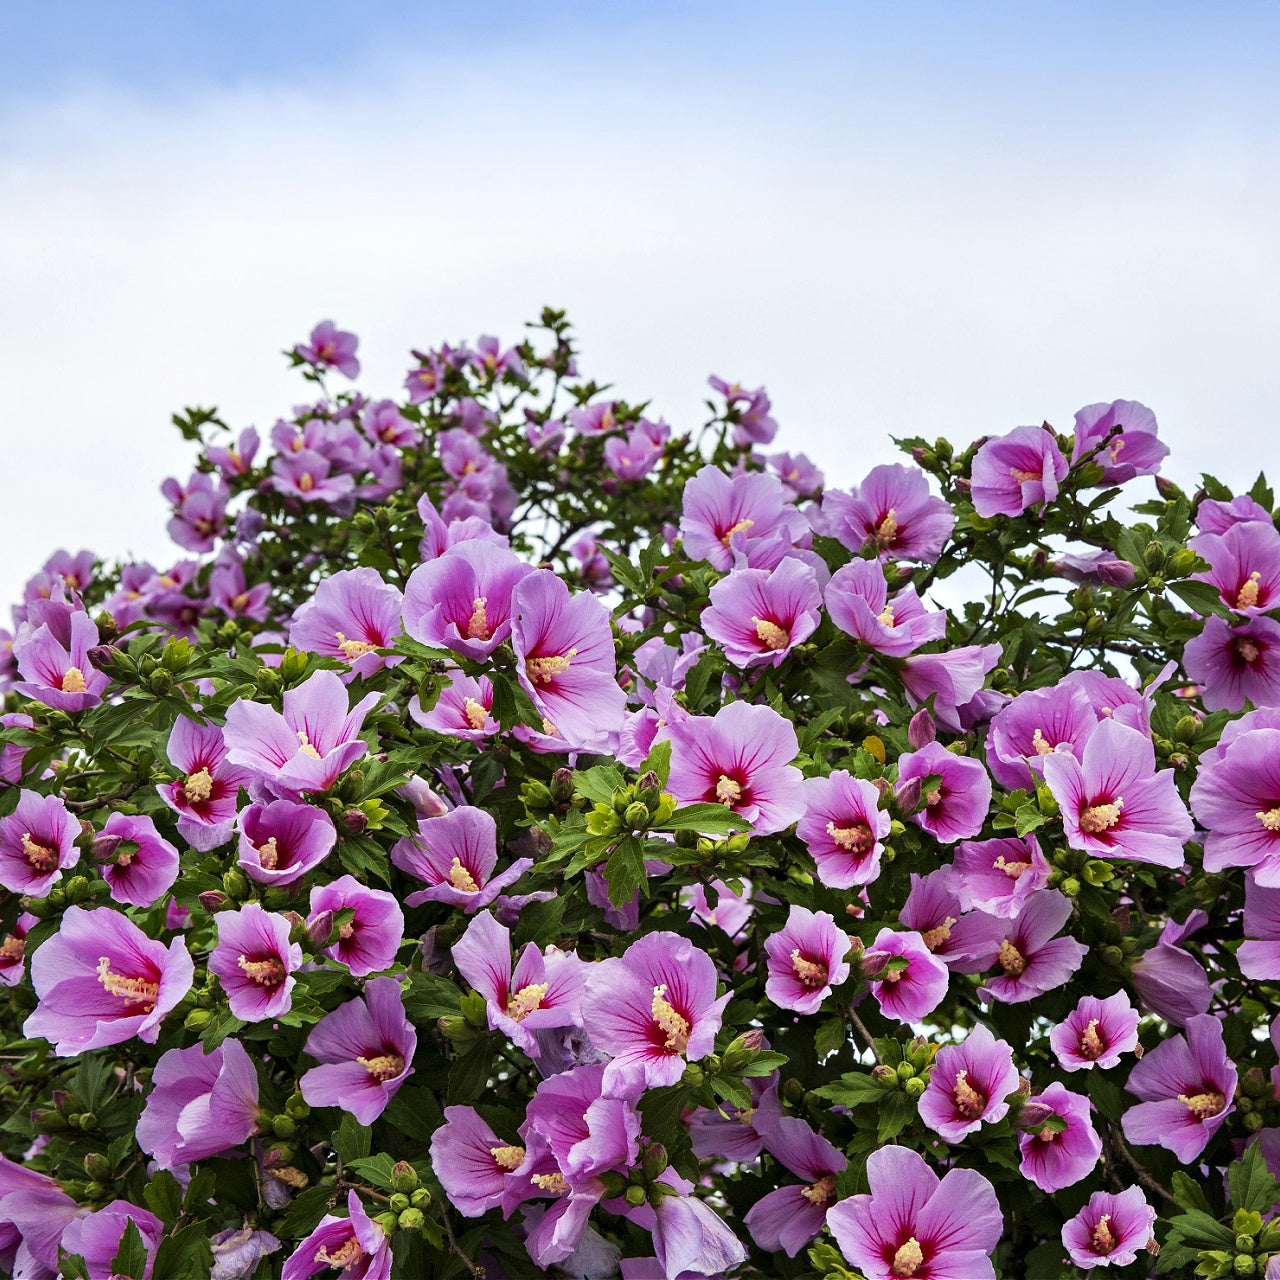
left=0, top=311, right=1280, bottom=1280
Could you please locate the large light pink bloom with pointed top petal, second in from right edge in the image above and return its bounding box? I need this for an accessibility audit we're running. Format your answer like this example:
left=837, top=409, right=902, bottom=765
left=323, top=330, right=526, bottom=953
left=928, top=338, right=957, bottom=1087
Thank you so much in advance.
left=1044, top=719, right=1194, bottom=867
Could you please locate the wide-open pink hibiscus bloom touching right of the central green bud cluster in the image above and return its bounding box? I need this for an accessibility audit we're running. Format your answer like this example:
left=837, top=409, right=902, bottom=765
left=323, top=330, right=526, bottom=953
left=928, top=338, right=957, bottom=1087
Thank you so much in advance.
left=667, top=703, right=805, bottom=836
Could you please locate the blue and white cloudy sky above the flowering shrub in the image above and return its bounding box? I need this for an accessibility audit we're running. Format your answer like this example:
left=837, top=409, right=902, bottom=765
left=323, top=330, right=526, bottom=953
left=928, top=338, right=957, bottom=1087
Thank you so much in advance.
left=0, top=0, right=1280, bottom=598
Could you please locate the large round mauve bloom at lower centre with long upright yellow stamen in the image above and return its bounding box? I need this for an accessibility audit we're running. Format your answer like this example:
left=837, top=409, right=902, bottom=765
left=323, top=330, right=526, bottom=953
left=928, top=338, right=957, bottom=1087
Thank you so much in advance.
left=582, top=932, right=732, bottom=1097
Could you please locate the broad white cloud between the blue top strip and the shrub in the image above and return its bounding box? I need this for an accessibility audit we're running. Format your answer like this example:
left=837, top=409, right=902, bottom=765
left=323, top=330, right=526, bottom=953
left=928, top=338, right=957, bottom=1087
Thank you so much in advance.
left=0, top=41, right=1280, bottom=614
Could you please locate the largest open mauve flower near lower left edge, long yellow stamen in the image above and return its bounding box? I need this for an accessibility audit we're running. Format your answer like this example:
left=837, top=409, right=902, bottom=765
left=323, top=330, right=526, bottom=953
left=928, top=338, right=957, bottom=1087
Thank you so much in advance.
left=23, top=906, right=195, bottom=1057
